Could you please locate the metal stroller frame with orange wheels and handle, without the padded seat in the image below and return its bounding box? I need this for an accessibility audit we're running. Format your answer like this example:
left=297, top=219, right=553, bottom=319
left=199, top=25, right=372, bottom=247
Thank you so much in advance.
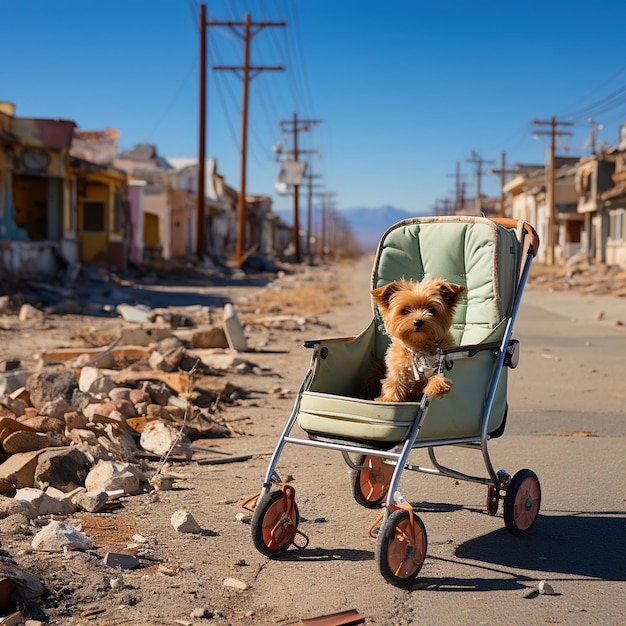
left=244, top=217, right=541, bottom=586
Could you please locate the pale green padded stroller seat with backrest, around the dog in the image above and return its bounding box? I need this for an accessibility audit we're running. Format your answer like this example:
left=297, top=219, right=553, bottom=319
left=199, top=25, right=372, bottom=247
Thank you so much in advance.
left=298, top=217, right=522, bottom=448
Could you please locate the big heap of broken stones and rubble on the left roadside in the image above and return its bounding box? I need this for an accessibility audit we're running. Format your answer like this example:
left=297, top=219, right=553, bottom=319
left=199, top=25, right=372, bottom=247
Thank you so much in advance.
left=0, top=305, right=259, bottom=519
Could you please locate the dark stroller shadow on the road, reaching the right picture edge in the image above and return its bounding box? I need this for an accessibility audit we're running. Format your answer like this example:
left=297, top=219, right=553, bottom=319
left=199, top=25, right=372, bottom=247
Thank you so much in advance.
left=455, top=511, right=626, bottom=581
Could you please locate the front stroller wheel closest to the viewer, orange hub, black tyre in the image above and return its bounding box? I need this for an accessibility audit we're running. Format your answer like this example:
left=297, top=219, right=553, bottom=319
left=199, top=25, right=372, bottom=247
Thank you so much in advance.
left=375, top=509, right=428, bottom=587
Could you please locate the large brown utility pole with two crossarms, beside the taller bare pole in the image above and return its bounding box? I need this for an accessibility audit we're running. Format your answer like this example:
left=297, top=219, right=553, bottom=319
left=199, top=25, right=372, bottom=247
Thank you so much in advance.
left=206, top=10, right=286, bottom=265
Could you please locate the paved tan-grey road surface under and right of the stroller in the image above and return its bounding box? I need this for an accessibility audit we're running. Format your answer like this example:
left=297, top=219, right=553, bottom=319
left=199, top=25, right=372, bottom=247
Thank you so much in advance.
left=243, top=255, right=626, bottom=626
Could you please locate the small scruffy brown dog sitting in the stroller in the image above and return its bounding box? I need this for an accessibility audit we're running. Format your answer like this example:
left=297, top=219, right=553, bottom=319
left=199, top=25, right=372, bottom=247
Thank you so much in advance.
left=372, top=278, right=465, bottom=402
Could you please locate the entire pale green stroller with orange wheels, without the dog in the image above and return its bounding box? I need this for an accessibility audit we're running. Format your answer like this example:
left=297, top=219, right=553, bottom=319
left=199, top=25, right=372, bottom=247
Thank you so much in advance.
left=243, top=216, right=541, bottom=586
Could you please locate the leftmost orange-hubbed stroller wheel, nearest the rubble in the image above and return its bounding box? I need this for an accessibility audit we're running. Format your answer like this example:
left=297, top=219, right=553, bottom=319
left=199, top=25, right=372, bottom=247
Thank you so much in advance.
left=250, top=491, right=300, bottom=558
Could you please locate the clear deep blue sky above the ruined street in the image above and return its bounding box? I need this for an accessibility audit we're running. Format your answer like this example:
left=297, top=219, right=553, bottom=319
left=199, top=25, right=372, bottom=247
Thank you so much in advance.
left=0, top=0, right=626, bottom=213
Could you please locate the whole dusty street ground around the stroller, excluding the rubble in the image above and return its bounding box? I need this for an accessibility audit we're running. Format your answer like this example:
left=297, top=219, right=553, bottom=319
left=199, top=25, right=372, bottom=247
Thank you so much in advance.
left=0, top=259, right=626, bottom=626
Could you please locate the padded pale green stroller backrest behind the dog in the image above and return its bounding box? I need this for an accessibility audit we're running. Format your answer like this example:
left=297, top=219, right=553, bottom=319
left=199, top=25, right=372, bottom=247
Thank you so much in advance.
left=372, top=216, right=522, bottom=346
